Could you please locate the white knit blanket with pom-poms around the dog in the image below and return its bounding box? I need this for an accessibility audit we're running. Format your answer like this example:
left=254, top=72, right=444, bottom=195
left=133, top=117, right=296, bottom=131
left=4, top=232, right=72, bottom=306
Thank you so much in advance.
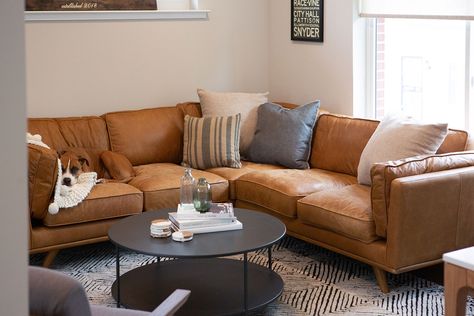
left=26, top=133, right=97, bottom=215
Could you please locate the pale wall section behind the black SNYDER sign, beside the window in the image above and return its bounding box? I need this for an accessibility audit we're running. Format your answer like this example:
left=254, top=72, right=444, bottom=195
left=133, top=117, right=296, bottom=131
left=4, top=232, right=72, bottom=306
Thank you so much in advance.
left=270, top=0, right=354, bottom=115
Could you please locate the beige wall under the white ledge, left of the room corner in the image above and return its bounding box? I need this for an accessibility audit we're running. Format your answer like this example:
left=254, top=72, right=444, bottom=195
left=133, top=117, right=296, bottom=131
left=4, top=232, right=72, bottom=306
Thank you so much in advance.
left=26, top=0, right=274, bottom=117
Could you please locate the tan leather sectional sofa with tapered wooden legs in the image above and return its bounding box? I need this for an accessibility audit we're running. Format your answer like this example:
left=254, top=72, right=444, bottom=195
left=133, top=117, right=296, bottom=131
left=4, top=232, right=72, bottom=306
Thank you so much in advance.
left=28, top=103, right=474, bottom=292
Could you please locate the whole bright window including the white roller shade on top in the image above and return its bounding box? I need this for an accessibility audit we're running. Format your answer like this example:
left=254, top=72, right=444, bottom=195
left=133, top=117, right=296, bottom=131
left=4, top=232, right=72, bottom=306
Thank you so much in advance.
left=359, top=0, right=474, bottom=131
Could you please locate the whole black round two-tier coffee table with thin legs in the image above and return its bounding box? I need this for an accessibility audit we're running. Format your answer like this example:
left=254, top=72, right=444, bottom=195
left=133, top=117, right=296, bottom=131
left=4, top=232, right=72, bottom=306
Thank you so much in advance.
left=109, top=208, right=286, bottom=315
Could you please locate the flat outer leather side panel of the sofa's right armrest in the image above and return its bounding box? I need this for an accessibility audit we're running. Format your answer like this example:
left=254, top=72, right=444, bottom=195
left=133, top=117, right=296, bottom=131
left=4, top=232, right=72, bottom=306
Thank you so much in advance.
left=387, top=167, right=474, bottom=270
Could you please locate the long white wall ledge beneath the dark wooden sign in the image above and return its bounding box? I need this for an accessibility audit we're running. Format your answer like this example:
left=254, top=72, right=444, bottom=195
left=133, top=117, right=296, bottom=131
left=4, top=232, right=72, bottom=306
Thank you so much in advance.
left=25, top=10, right=211, bottom=21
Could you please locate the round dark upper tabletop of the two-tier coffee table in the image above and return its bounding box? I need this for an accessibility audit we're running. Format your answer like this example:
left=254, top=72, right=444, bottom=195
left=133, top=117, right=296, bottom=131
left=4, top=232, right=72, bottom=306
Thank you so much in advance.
left=109, top=208, right=286, bottom=258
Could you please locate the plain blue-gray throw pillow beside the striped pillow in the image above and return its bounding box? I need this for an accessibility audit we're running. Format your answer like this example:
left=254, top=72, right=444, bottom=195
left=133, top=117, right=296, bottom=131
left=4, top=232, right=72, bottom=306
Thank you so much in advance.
left=245, top=101, right=319, bottom=169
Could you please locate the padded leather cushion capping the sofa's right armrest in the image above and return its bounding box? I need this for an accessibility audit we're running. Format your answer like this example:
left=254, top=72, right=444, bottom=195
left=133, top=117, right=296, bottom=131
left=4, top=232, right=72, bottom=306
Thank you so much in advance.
left=371, top=151, right=474, bottom=237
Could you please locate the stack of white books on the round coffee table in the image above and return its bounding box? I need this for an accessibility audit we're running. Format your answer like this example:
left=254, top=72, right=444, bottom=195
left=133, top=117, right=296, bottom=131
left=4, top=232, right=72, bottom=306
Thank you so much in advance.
left=168, top=203, right=242, bottom=234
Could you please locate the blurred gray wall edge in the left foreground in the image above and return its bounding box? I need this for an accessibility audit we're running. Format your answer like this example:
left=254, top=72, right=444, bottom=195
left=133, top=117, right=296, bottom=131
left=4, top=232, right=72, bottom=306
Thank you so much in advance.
left=0, top=0, right=28, bottom=316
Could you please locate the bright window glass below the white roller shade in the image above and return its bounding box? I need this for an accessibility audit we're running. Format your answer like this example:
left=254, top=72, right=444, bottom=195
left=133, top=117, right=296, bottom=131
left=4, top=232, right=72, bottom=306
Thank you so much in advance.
left=373, top=18, right=474, bottom=129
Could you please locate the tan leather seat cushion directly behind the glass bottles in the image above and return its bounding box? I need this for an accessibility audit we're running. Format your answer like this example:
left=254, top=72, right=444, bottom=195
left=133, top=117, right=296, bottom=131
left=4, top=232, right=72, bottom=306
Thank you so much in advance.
left=128, top=163, right=229, bottom=211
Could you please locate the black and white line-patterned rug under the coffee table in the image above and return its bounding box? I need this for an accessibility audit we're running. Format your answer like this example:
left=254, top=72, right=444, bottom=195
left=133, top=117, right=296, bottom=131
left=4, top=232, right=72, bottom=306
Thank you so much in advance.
left=30, top=237, right=474, bottom=316
